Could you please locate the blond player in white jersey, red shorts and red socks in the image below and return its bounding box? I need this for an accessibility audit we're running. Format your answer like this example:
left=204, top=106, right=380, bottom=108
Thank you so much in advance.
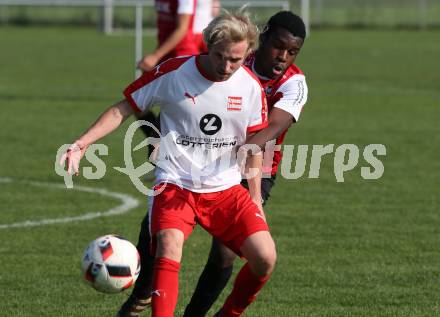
left=60, top=13, right=276, bottom=317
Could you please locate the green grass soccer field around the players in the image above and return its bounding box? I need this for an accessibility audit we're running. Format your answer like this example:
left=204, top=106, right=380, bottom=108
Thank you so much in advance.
left=0, top=28, right=440, bottom=317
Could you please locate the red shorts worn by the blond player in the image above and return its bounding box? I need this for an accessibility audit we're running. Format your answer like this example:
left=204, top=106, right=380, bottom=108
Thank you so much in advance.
left=150, top=184, right=269, bottom=254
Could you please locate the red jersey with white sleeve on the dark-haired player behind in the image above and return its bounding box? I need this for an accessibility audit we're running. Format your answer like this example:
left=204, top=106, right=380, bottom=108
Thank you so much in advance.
left=244, top=54, right=308, bottom=175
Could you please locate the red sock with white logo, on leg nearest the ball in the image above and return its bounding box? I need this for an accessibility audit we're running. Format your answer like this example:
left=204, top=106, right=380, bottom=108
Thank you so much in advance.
left=151, top=258, right=180, bottom=317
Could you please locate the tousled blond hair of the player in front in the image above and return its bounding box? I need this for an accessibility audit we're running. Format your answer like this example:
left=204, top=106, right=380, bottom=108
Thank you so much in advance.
left=203, top=9, right=258, bottom=51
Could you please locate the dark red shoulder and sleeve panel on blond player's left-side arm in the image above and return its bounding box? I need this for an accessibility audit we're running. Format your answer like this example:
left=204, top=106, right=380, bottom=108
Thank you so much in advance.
left=124, top=56, right=192, bottom=112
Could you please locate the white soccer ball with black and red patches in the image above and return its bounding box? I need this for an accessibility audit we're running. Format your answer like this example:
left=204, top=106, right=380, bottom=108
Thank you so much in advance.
left=81, top=235, right=141, bottom=293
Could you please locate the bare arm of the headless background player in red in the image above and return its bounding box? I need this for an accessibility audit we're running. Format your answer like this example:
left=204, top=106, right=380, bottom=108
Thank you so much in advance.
left=138, top=14, right=191, bottom=71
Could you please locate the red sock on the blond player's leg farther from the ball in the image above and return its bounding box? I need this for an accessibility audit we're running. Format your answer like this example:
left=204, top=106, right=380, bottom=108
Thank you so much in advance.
left=221, top=263, right=269, bottom=317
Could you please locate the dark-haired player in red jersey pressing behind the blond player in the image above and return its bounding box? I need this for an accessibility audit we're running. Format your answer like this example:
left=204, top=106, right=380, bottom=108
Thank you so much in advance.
left=184, top=11, right=307, bottom=317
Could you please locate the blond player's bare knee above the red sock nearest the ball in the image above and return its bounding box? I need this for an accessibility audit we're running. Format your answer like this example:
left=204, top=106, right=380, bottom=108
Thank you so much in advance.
left=156, top=229, right=184, bottom=262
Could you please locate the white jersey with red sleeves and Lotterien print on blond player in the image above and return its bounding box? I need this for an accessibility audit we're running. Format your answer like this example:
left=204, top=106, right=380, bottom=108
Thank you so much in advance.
left=124, top=56, right=267, bottom=192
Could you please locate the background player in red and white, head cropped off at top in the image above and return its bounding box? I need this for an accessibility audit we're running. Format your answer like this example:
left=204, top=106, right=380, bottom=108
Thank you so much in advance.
left=137, top=0, right=198, bottom=160
